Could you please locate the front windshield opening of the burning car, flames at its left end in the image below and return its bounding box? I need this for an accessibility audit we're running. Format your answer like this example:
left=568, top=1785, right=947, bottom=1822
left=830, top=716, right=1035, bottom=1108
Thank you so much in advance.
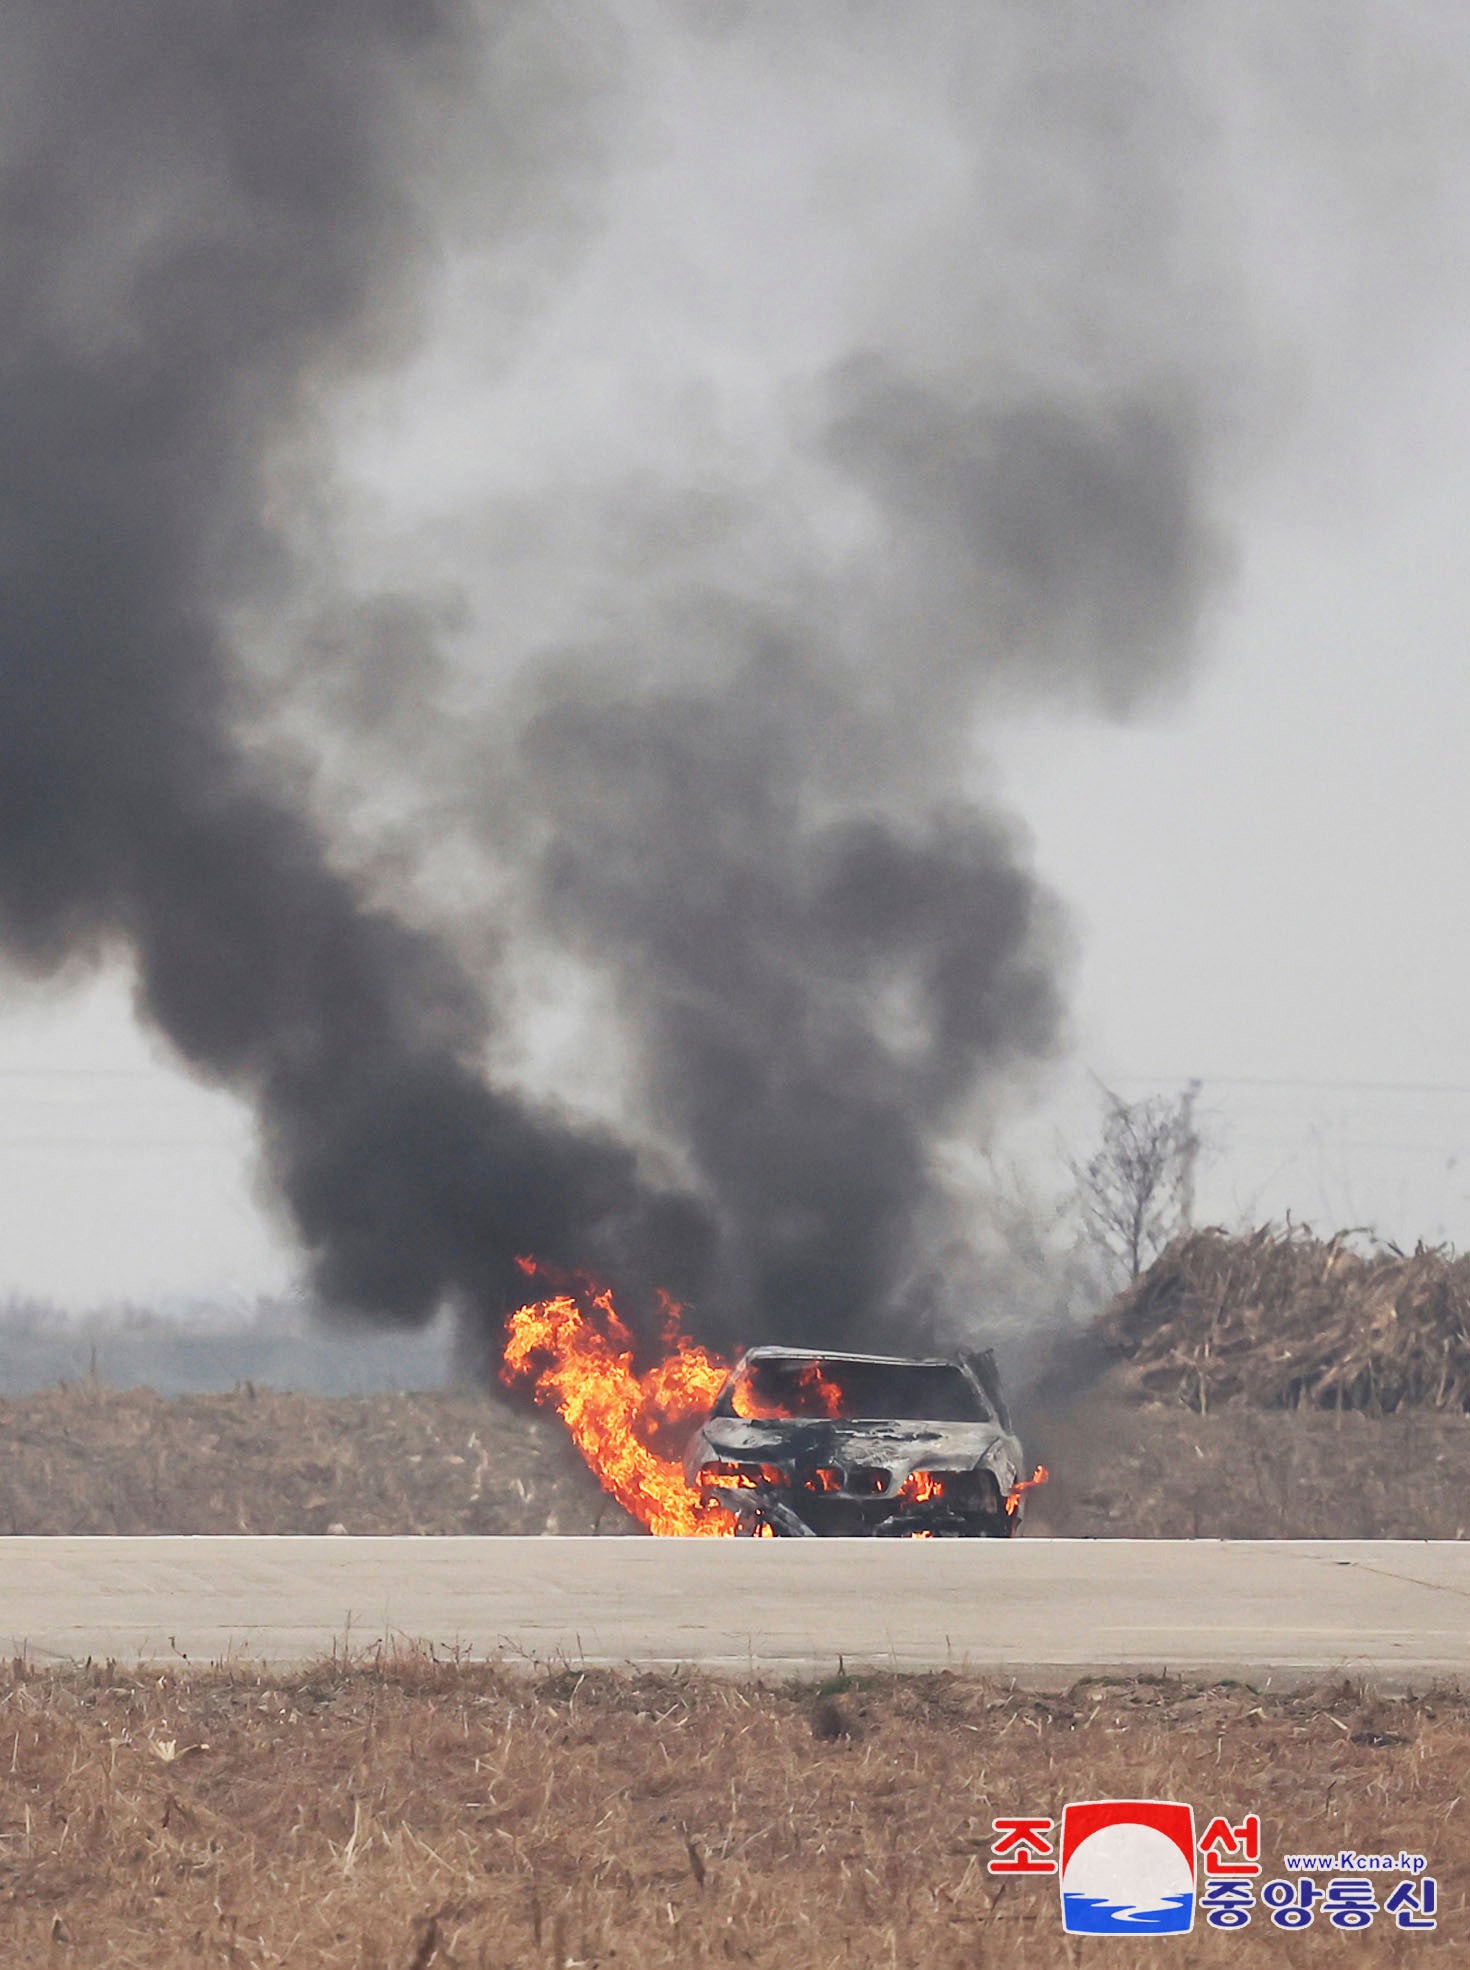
left=715, top=1355, right=993, bottom=1422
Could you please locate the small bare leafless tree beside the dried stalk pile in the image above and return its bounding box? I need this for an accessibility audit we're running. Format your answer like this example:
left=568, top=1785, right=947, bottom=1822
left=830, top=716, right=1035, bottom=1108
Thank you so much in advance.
left=1070, top=1082, right=1200, bottom=1279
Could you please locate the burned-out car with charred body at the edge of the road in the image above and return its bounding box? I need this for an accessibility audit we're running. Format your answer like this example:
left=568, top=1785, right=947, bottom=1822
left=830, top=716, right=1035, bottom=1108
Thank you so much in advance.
left=684, top=1347, right=1023, bottom=1539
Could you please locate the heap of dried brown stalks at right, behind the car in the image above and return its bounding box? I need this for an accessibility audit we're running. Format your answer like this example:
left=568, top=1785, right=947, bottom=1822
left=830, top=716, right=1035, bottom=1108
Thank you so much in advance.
left=1098, top=1225, right=1470, bottom=1412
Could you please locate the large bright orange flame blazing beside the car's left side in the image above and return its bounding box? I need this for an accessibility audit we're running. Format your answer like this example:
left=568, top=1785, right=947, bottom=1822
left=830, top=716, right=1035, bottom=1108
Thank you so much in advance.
left=501, top=1259, right=735, bottom=1539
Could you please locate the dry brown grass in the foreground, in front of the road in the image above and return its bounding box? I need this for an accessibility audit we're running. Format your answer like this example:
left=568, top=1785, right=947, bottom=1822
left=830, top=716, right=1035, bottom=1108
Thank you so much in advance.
left=0, top=1657, right=1470, bottom=1970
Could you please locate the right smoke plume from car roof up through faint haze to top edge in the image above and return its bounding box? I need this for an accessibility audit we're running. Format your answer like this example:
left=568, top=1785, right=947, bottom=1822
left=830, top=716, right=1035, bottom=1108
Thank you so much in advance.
left=453, top=6, right=1232, bottom=1346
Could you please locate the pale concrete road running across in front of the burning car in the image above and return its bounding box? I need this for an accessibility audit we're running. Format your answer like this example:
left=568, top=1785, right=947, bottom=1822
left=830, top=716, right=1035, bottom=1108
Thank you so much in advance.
left=0, top=1539, right=1470, bottom=1688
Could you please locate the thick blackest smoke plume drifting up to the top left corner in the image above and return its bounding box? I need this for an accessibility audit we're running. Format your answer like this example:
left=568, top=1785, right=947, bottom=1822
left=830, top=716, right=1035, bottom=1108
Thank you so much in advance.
left=0, top=0, right=707, bottom=1320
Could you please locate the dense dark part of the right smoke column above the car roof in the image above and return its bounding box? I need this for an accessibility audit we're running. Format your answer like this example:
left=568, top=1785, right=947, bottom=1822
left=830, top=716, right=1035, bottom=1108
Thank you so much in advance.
left=486, top=380, right=1216, bottom=1346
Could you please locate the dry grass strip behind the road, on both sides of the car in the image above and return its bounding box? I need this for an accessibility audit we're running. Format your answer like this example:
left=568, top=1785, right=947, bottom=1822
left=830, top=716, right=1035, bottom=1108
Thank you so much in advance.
left=0, top=1385, right=1470, bottom=1539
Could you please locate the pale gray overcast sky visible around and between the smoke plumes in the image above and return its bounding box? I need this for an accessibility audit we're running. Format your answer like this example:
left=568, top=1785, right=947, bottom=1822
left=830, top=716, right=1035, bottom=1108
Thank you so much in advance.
left=0, top=11, right=1470, bottom=1306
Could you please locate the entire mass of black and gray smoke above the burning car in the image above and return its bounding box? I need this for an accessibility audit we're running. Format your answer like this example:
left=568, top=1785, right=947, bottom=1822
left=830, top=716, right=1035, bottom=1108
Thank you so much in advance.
left=0, top=0, right=1458, bottom=1342
